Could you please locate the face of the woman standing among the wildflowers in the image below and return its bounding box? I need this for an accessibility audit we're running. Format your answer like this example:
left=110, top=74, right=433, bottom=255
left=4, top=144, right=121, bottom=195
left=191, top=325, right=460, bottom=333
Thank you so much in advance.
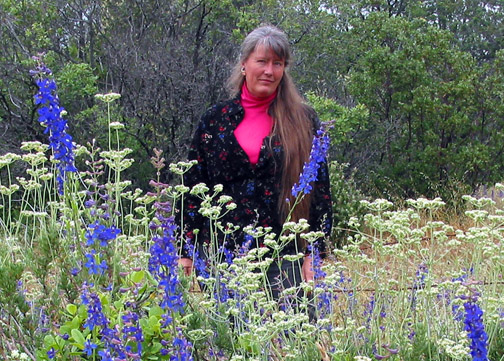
left=242, top=45, right=285, bottom=98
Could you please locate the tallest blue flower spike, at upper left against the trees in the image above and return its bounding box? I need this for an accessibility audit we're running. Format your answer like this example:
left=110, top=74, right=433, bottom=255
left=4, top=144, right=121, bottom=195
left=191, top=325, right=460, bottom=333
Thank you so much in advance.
left=30, top=58, right=77, bottom=194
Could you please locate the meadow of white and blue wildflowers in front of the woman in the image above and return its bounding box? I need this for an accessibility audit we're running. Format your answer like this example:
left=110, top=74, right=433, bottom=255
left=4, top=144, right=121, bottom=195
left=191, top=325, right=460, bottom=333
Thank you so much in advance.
left=0, top=62, right=504, bottom=361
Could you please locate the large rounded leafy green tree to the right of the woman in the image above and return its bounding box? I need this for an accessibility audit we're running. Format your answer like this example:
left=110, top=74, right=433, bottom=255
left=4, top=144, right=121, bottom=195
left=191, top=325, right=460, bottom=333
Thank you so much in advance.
left=349, top=13, right=500, bottom=196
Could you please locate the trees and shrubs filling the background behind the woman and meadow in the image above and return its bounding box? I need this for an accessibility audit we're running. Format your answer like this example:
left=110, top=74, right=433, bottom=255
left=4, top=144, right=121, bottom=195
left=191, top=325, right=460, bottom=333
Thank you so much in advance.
left=0, top=0, right=504, bottom=197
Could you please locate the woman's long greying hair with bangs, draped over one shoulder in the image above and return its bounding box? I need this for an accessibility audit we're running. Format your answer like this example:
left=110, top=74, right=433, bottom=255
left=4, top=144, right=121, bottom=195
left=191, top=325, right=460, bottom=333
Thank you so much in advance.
left=227, top=25, right=313, bottom=225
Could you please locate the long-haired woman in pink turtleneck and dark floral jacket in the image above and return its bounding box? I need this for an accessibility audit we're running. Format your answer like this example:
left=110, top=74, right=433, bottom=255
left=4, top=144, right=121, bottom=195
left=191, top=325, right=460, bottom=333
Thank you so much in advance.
left=176, top=26, right=332, bottom=294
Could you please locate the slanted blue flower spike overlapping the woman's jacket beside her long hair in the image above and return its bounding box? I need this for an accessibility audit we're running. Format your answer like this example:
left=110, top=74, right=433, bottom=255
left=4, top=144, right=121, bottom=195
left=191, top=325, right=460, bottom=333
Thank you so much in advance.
left=291, top=124, right=329, bottom=197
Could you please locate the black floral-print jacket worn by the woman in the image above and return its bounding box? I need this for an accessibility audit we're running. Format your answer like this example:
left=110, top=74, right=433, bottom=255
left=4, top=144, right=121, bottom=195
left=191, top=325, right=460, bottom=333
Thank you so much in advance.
left=179, top=97, right=332, bottom=257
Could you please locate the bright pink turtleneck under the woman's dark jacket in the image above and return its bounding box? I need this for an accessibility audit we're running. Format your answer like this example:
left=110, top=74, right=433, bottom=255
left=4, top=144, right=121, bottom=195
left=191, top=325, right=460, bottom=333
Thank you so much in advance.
left=234, top=83, right=276, bottom=165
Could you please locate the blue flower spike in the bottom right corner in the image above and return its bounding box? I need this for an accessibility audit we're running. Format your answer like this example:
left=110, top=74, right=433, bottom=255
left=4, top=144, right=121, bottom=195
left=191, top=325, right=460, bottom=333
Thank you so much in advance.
left=464, top=294, right=488, bottom=361
